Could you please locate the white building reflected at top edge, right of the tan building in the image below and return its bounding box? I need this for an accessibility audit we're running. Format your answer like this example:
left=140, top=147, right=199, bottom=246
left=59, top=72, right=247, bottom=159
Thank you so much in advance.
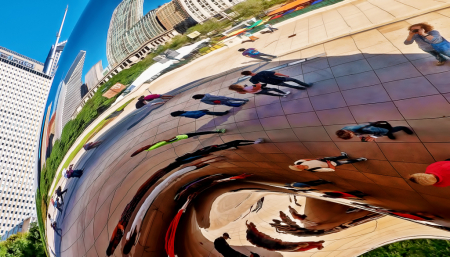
left=179, top=0, right=245, bottom=23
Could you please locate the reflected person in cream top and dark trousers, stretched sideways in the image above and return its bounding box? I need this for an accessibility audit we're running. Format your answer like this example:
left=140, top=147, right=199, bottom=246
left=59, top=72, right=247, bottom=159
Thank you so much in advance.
left=289, top=152, right=367, bottom=172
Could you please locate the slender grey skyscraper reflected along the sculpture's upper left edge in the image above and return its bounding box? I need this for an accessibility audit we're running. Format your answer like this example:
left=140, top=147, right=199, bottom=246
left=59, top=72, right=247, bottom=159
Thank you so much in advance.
left=55, top=50, right=86, bottom=138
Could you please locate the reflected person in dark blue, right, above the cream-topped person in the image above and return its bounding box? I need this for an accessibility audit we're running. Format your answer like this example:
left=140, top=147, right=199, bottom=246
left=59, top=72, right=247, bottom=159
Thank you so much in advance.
left=336, top=121, right=414, bottom=142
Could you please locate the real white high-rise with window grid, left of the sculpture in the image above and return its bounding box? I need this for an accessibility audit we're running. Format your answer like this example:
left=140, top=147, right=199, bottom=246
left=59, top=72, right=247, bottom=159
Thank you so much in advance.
left=0, top=47, right=51, bottom=234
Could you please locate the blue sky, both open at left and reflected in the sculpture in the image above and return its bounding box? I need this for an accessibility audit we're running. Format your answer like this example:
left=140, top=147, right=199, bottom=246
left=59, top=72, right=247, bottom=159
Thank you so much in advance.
left=9, top=0, right=168, bottom=116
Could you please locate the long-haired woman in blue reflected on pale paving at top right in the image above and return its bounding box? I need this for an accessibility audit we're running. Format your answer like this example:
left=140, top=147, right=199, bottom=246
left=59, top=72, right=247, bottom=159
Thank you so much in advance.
left=404, top=22, right=450, bottom=66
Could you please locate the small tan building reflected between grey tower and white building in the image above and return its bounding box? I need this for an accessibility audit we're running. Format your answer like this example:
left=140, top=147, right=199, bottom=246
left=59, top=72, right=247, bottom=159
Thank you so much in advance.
left=156, top=0, right=197, bottom=33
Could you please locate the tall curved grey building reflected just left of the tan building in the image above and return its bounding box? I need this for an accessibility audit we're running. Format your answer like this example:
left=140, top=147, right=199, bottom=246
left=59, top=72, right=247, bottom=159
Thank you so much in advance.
left=106, top=0, right=177, bottom=67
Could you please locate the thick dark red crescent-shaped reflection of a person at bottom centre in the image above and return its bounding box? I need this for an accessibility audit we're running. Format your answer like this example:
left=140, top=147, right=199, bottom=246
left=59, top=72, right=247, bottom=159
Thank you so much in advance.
left=245, top=221, right=325, bottom=252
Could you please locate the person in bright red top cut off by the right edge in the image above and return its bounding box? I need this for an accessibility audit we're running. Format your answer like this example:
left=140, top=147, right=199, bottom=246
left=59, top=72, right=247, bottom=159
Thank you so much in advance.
left=409, top=159, right=450, bottom=187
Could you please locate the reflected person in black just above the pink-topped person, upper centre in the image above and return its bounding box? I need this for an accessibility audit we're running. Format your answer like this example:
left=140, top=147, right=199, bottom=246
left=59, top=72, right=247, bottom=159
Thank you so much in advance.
left=241, top=70, right=313, bottom=89
